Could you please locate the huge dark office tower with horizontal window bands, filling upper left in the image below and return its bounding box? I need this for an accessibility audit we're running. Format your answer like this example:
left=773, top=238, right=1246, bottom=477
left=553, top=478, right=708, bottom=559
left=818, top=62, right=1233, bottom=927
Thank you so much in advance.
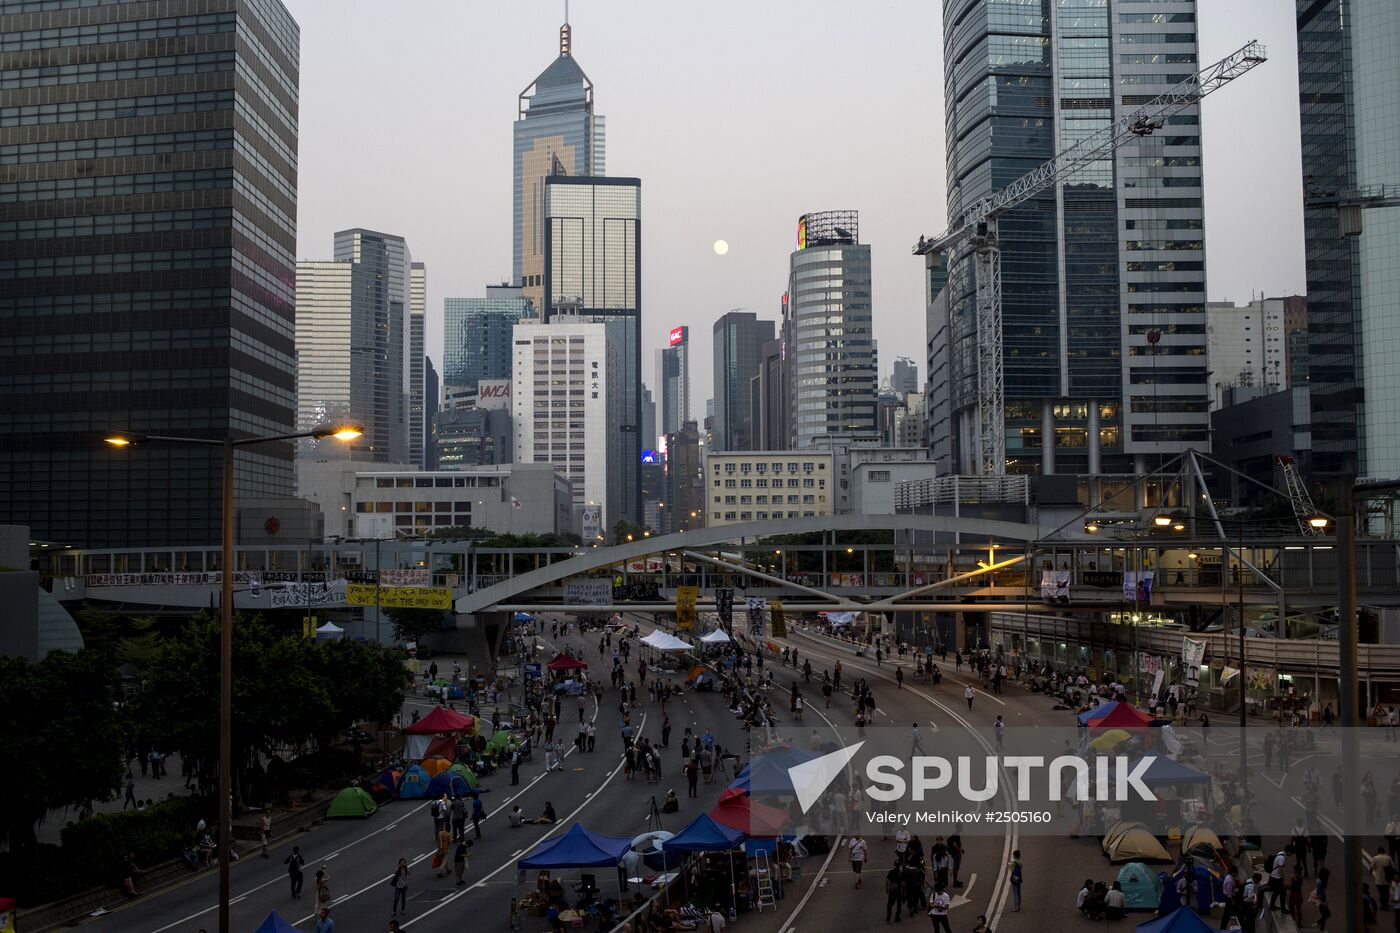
left=0, top=0, right=300, bottom=546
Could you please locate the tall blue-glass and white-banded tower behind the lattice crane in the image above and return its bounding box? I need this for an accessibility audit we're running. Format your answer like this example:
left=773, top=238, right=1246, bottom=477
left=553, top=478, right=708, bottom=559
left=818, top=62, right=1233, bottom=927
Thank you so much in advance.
left=928, top=0, right=1210, bottom=474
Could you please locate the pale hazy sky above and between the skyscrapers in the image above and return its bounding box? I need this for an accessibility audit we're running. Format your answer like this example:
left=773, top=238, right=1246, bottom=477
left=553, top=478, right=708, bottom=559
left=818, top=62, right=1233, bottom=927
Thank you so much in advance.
left=284, top=0, right=1305, bottom=406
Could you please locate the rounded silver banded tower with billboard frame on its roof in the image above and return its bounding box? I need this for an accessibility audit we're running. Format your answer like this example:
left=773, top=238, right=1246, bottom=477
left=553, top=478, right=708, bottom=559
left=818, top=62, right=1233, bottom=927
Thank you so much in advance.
left=783, top=210, right=878, bottom=450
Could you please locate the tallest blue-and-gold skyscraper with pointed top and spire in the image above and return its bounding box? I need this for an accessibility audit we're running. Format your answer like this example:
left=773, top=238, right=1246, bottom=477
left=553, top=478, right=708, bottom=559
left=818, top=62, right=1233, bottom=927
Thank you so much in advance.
left=511, top=13, right=605, bottom=311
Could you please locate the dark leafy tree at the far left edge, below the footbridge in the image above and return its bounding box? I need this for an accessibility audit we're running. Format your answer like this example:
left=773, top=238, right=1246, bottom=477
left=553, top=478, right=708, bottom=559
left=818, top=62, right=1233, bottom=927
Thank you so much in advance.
left=0, top=650, right=123, bottom=855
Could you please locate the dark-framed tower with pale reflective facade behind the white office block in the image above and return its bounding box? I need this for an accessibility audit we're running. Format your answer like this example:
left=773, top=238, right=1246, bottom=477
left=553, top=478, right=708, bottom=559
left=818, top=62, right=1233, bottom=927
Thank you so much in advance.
left=543, top=175, right=643, bottom=528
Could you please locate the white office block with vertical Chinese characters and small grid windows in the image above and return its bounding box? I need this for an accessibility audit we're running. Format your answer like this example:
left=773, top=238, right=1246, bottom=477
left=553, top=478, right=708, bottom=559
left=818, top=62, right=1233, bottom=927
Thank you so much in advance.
left=511, top=317, right=616, bottom=527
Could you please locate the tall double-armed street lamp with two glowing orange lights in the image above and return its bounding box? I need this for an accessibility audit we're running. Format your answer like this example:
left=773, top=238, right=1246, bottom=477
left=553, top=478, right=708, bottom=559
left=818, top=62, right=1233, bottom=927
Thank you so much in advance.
left=102, top=422, right=364, bottom=933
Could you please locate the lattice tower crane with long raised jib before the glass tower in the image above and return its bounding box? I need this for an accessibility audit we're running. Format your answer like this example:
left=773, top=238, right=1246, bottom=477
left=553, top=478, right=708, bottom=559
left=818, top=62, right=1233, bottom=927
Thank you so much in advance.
left=914, top=41, right=1268, bottom=475
